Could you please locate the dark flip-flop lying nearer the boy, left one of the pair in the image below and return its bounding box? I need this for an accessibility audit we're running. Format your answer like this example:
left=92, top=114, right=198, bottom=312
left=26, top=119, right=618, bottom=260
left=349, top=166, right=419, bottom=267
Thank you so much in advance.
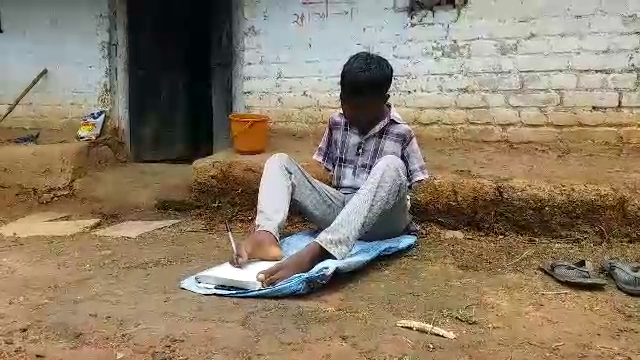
left=540, top=260, right=607, bottom=287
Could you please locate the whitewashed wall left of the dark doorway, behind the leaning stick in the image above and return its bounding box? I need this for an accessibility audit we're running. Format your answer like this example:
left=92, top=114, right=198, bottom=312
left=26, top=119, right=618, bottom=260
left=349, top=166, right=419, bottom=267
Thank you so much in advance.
left=0, top=0, right=109, bottom=126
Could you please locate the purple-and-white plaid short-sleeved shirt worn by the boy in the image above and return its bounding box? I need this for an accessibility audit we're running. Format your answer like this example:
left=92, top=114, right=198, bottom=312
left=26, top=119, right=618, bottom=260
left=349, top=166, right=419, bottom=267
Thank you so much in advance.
left=313, top=107, right=429, bottom=193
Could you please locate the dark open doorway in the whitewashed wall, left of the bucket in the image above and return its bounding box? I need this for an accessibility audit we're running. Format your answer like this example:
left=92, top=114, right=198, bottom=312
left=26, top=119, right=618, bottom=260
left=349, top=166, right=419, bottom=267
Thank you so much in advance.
left=127, top=0, right=233, bottom=161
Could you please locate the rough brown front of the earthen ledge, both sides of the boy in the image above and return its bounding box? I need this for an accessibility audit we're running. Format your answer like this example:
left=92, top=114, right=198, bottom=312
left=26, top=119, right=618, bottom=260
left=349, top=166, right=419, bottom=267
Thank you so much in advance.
left=192, top=153, right=640, bottom=240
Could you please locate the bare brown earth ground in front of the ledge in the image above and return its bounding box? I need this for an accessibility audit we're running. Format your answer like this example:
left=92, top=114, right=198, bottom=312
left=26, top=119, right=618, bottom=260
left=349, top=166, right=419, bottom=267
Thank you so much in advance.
left=0, top=204, right=640, bottom=360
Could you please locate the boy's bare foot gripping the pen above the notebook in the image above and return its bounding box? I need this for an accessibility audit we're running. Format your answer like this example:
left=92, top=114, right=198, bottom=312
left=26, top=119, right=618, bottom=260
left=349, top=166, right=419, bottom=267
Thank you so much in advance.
left=229, top=231, right=282, bottom=267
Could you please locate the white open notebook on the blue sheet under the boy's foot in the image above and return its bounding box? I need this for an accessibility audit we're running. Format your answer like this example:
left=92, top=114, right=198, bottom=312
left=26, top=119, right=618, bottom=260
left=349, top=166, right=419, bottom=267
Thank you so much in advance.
left=195, top=261, right=278, bottom=290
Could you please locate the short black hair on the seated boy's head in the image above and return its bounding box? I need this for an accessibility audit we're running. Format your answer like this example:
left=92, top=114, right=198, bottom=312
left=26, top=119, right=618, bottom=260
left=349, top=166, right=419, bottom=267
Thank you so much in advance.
left=340, top=51, right=393, bottom=98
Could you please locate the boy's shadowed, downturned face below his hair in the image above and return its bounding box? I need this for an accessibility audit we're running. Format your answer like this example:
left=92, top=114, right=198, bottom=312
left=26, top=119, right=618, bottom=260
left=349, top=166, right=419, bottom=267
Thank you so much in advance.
left=340, top=95, right=389, bottom=133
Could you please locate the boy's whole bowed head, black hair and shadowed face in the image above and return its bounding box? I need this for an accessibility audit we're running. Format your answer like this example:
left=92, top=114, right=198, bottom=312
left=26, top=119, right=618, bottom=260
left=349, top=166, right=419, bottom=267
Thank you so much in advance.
left=340, top=52, right=393, bottom=131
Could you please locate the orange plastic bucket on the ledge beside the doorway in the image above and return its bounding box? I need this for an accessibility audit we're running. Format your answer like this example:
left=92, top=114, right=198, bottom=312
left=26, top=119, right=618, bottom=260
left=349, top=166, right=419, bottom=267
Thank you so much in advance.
left=229, top=114, right=269, bottom=155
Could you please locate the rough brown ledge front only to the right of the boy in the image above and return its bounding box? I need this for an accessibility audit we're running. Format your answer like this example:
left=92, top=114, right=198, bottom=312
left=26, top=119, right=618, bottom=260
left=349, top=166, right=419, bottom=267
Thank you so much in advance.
left=412, top=175, right=640, bottom=239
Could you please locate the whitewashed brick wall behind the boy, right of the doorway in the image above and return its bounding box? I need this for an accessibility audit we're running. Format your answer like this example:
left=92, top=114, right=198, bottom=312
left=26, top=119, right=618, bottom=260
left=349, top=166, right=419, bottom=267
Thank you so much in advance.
left=242, top=0, right=640, bottom=143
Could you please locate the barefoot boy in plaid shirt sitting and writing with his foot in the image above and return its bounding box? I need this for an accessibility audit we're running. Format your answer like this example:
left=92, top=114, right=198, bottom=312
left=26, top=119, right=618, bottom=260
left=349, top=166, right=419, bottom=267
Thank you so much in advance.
left=231, top=52, right=428, bottom=286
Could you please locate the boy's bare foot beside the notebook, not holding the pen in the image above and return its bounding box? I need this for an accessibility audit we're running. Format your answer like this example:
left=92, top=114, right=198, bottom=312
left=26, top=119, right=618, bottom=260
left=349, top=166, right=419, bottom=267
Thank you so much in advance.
left=257, top=241, right=330, bottom=286
